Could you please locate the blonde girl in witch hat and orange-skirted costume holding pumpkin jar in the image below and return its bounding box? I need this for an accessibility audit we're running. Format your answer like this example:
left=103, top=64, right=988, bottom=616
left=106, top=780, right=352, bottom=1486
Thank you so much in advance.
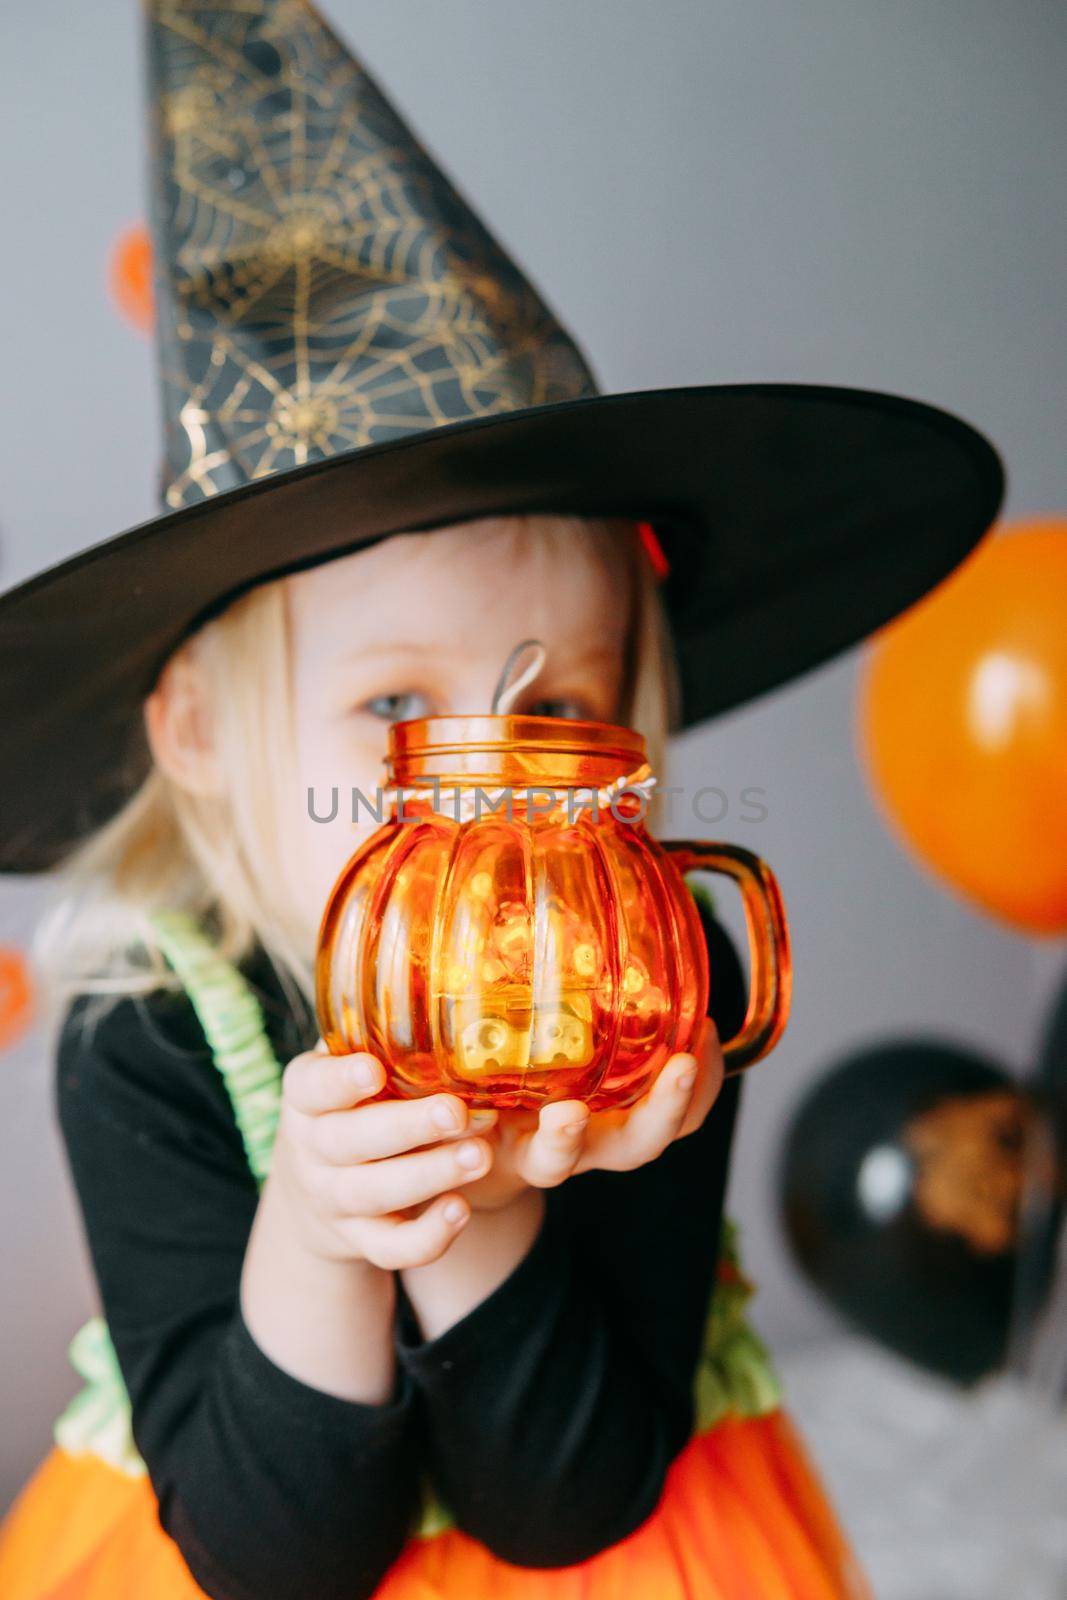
left=0, top=0, right=1000, bottom=1600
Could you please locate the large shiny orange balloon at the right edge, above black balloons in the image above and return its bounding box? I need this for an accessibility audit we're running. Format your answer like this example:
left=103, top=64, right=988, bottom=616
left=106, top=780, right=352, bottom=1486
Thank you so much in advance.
left=859, top=517, right=1067, bottom=934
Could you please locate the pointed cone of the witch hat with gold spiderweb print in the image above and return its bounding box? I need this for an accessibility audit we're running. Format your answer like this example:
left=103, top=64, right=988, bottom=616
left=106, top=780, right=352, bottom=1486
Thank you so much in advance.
left=149, top=0, right=597, bottom=507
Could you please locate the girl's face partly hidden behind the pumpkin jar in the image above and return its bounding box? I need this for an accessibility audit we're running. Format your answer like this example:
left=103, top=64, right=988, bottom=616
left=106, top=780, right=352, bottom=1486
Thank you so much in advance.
left=286, top=517, right=630, bottom=930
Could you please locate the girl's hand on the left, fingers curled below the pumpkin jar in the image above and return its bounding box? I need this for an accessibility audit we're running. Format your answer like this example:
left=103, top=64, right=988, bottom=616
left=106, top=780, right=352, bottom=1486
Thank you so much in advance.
left=270, top=1045, right=496, bottom=1272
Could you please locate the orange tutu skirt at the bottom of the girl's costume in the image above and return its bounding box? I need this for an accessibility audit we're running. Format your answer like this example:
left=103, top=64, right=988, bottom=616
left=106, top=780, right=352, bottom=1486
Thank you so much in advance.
left=0, top=1411, right=869, bottom=1600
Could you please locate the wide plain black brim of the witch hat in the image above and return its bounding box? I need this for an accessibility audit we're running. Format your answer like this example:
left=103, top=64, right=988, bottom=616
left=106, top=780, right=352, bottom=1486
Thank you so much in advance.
left=0, top=384, right=1003, bottom=872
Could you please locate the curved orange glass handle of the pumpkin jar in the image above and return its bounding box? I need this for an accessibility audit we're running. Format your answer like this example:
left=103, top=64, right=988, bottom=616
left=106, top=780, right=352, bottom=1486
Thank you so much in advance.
left=661, top=838, right=793, bottom=1077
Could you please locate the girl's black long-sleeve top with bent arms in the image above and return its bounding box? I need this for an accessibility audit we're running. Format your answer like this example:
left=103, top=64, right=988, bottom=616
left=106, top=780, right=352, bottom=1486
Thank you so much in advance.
left=58, top=918, right=744, bottom=1600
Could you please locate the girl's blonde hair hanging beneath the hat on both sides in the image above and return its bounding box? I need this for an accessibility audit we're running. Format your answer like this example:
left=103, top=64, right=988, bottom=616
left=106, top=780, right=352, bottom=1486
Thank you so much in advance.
left=35, top=515, right=678, bottom=1014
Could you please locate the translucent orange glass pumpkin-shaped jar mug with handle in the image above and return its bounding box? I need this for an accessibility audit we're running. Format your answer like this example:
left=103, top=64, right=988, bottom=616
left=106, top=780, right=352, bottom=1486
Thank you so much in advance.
left=317, top=715, right=790, bottom=1107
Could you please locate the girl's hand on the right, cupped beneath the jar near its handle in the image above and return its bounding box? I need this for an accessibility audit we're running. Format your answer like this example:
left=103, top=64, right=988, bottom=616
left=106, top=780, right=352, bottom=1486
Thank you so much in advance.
left=467, top=1018, right=723, bottom=1210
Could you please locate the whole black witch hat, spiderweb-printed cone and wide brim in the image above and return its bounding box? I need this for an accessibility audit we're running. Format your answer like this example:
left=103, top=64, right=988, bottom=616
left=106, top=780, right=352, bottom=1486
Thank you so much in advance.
left=0, top=0, right=1003, bottom=872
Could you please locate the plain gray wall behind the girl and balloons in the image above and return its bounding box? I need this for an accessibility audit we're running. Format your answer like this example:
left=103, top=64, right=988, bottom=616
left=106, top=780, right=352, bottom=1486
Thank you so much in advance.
left=0, top=0, right=1067, bottom=1499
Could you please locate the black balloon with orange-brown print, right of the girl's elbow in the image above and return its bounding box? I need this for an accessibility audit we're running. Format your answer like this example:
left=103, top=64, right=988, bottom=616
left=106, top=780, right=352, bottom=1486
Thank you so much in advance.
left=781, top=1040, right=1041, bottom=1384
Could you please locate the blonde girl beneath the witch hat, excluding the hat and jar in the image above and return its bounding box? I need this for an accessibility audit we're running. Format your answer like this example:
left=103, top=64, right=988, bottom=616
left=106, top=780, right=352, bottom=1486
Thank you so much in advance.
left=0, top=517, right=854, bottom=1600
